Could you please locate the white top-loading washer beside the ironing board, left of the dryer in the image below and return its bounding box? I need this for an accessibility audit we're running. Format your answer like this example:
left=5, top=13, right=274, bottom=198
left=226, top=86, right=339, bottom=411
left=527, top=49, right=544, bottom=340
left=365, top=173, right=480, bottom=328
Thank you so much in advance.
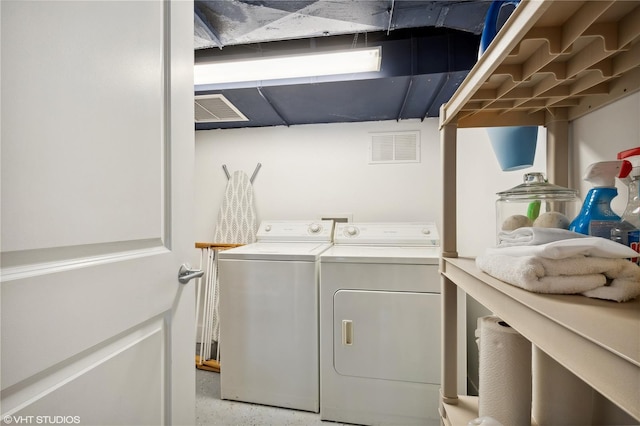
left=218, top=220, right=333, bottom=413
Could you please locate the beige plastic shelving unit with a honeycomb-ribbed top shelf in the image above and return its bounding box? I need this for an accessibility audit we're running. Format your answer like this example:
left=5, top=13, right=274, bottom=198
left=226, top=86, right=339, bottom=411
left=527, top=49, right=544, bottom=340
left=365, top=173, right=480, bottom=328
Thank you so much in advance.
left=440, top=0, right=640, bottom=425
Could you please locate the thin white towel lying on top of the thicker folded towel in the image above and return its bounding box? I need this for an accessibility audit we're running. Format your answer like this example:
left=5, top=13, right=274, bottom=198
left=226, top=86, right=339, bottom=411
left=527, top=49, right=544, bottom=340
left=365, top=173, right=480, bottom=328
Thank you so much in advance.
left=486, top=237, right=638, bottom=259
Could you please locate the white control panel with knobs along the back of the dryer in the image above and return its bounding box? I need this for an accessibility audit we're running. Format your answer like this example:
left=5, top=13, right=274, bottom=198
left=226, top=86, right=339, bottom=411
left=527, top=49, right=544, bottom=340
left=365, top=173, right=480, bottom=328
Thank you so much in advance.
left=333, top=222, right=440, bottom=247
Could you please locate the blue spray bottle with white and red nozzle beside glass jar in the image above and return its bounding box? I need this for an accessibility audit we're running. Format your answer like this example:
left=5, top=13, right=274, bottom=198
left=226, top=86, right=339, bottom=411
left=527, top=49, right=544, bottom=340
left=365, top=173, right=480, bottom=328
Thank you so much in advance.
left=569, top=160, right=631, bottom=239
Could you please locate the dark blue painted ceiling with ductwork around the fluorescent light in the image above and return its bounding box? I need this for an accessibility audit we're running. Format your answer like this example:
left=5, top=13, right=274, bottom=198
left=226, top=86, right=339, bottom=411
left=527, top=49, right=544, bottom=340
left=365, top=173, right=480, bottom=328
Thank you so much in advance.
left=195, top=0, right=490, bottom=130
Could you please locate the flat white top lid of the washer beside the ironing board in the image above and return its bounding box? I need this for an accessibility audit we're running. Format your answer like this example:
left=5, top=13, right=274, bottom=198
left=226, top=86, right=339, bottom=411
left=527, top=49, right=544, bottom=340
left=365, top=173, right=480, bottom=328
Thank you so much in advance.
left=218, top=242, right=331, bottom=262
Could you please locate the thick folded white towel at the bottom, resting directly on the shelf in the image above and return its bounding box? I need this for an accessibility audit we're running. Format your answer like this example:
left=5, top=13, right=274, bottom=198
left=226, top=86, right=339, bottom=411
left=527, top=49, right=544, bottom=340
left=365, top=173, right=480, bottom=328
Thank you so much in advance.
left=476, top=255, right=640, bottom=302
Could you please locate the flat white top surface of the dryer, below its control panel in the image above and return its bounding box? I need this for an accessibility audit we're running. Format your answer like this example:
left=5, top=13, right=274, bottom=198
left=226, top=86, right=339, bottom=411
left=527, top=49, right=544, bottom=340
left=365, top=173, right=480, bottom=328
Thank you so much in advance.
left=320, top=245, right=440, bottom=265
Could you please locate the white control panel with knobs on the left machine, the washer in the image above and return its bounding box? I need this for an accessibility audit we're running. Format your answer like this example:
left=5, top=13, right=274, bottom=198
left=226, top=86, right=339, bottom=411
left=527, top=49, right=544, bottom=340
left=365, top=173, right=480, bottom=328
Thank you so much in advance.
left=256, top=220, right=333, bottom=242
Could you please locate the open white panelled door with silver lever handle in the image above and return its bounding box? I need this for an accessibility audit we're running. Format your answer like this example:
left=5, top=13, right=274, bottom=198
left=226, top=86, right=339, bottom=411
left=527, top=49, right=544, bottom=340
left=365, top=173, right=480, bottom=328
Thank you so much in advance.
left=0, top=0, right=195, bottom=425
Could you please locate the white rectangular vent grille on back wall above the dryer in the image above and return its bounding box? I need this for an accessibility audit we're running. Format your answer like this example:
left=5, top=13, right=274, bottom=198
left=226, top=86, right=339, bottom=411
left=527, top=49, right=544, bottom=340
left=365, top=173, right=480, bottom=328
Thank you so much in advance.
left=369, top=131, right=420, bottom=164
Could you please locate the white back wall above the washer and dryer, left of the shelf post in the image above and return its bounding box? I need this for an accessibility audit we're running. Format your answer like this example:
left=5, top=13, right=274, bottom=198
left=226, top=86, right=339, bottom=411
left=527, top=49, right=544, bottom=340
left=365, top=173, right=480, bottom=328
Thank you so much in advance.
left=196, top=119, right=442, bottom=241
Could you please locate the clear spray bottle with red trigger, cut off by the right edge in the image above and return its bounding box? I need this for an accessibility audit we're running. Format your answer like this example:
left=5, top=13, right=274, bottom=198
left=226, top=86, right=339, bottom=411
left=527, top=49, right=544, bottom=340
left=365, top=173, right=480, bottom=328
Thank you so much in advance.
left=611, top=147, right=640, bottom=263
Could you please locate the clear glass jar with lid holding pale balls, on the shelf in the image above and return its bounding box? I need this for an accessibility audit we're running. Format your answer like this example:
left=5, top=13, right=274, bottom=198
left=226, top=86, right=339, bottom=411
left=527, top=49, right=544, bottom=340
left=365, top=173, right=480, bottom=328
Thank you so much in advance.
left=496, top=173, right=581, bottom=233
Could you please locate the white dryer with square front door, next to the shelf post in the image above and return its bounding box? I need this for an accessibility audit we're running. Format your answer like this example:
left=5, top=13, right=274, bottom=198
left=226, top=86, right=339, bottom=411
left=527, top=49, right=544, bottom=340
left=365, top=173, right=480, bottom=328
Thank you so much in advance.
left=320, top=223, right=441, bottom=425
